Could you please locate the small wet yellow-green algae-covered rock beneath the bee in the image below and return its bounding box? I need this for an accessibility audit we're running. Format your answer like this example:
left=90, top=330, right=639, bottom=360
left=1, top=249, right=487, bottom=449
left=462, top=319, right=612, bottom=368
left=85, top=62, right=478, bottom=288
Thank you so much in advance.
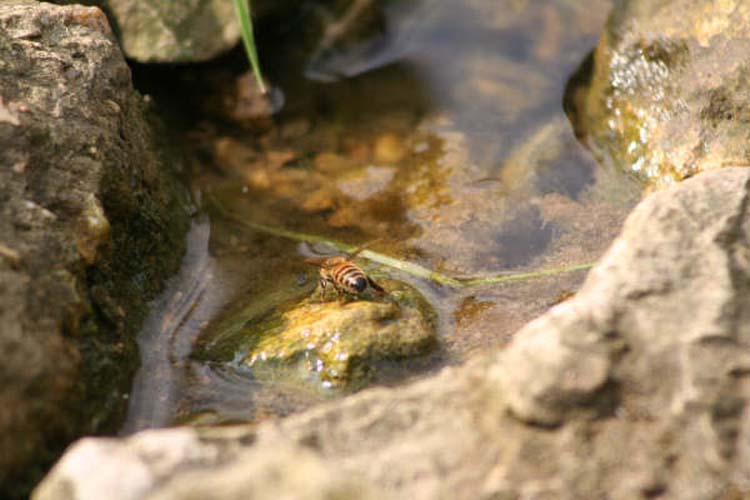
left=199, top=280, right=437, bottom=389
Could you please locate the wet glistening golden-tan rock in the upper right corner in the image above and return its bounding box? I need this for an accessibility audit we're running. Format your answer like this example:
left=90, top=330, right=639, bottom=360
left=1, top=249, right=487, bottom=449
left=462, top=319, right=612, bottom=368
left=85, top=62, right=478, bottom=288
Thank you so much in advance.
left=573, top=0, right=750, bottom=186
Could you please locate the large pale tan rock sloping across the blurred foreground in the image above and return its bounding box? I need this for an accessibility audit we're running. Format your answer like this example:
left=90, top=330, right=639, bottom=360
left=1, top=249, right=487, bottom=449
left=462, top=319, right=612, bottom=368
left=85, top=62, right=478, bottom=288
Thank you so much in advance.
left=34, top=168, right=750, bottom=500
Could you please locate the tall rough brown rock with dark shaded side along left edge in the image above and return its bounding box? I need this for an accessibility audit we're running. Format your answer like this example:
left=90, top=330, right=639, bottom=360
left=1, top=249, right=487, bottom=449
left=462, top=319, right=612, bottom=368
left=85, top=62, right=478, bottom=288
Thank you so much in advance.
left=0, top=0, right=188, bottom=498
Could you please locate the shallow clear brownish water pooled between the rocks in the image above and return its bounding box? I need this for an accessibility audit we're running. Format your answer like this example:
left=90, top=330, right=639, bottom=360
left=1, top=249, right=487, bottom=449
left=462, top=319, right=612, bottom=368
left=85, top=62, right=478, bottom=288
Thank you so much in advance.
left=125, top=0, right=640, bottom=432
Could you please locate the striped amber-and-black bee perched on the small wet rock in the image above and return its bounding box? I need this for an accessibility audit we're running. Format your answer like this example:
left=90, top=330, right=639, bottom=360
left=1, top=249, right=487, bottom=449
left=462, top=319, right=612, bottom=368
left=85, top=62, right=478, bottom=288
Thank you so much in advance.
left=305, top=246, right=385, bottom=297
